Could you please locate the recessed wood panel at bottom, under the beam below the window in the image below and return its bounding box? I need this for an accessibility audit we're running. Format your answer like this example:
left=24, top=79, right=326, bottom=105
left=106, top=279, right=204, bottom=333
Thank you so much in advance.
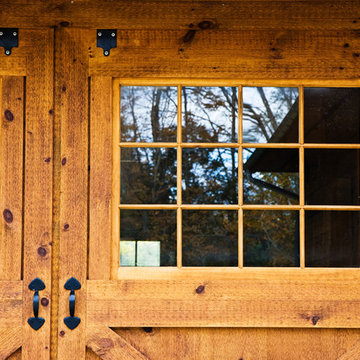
left=87, top=328, right=360, bottom=360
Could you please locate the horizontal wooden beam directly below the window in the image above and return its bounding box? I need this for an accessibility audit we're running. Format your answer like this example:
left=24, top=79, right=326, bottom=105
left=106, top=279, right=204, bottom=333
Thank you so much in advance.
left=87, top=269, right=360, bottom=328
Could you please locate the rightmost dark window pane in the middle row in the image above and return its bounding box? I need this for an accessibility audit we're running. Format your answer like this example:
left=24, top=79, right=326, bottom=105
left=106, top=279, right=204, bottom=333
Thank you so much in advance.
left=305, top=149, right=360, bottom=205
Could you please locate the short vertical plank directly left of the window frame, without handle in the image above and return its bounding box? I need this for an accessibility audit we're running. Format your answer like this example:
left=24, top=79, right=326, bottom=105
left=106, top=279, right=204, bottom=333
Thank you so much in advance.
left=89, top=76, right=112, bottom=280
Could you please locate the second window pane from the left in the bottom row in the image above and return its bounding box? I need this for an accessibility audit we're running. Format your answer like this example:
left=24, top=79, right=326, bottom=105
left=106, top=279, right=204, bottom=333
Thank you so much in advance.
left=182, top=210, right=238, bottom=266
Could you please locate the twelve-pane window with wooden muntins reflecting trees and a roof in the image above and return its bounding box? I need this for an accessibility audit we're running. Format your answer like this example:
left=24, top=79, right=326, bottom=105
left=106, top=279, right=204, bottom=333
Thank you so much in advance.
left=114, top=84, right=360, bottom=268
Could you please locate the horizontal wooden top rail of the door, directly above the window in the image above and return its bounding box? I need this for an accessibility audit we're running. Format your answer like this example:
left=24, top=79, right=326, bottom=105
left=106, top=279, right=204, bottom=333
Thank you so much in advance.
left=84, top=30, right=360, bottom=79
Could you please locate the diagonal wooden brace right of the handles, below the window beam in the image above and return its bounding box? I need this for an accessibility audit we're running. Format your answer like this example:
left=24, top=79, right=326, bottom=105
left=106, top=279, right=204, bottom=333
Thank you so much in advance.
left=86, top=326, right=150, bottom=360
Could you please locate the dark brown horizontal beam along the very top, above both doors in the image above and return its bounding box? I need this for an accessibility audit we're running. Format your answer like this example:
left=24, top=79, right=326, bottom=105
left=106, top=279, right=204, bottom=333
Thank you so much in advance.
left=0, top=0, right=360, bottom=30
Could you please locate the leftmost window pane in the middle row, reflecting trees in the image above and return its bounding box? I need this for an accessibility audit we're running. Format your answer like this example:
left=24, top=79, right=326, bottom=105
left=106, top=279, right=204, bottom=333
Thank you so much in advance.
left=120, top=148, right=176, bottom=204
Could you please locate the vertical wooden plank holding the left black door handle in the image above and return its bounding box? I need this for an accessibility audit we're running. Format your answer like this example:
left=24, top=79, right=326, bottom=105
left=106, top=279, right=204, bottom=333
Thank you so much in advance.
left=22, top=29, right=53, bottom=360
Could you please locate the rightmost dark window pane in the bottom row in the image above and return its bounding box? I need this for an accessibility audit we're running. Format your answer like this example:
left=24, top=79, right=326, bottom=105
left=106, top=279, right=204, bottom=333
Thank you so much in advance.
left=305, top=211, right=360, bottom=267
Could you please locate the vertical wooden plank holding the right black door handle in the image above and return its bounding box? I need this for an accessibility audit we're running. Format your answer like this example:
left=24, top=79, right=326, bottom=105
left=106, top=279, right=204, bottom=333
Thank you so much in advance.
left=55, top=28, right=89, bottom=360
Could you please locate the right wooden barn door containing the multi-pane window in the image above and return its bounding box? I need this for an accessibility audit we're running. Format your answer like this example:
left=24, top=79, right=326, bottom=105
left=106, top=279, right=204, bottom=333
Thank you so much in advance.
left=55, top=29, right=360, bottom=359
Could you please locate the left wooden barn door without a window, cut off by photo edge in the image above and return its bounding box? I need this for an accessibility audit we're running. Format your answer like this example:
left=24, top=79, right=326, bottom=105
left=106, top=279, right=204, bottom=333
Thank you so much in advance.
left=0, top=28, right=53, bottom=359
